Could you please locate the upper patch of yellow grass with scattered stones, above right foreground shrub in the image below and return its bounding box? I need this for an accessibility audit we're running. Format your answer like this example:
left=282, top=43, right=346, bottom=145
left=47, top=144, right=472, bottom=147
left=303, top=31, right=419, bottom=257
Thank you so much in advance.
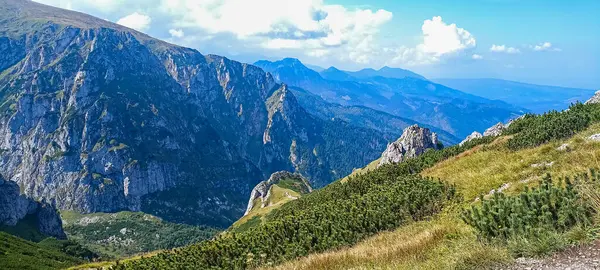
left=422, top=125, right=600, bottom=200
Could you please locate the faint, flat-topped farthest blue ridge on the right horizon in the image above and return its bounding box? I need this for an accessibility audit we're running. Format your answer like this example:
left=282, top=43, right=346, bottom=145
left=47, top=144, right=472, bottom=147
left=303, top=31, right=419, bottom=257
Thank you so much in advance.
left=434, top=79, right=595, bottom=113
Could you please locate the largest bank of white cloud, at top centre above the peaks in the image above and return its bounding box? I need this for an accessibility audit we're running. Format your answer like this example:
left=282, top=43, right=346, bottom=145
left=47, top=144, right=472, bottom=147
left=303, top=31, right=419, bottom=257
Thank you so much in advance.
left=161, top=0, right=392, bottom=63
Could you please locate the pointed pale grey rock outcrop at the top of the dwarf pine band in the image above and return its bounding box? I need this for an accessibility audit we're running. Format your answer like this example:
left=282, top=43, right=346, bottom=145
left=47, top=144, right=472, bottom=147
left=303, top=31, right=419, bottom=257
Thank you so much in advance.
left=377, top=125, right=438, bottom=167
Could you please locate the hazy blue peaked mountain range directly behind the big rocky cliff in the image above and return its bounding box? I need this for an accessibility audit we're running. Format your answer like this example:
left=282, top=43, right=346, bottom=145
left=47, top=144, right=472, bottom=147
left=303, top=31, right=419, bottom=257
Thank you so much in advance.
left=255, top=59, right=526, bottom=138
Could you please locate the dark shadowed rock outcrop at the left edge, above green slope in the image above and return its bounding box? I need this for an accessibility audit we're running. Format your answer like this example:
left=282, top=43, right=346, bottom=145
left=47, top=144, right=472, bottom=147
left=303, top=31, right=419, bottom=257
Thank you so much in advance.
left=0, top=176, right=66, bottom=239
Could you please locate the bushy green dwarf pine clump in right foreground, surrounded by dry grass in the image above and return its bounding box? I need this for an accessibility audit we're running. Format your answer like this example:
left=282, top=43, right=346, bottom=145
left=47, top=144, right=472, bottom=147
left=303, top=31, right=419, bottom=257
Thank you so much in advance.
left=462, top=175, right=593, bottom=239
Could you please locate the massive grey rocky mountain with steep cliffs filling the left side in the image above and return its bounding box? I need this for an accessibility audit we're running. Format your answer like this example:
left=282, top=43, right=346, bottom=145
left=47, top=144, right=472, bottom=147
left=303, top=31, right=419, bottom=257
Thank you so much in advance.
left=0, top=0, right=387, bottom=230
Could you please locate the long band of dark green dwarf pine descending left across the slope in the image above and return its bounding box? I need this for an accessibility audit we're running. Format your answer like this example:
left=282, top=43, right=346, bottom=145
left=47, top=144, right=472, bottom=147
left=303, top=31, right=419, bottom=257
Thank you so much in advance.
left=113, top=170, right=455, bottom=269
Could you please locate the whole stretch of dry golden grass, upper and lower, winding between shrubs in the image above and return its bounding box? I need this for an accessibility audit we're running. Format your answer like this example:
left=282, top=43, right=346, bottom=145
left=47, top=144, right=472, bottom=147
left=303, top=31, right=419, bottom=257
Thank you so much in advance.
left=268, top=124, right=600, bottom=269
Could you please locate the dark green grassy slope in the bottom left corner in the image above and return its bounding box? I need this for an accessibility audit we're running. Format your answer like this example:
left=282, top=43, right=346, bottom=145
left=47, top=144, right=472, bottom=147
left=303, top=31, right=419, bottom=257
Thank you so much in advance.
left=0, top=232, right=83, bottom=270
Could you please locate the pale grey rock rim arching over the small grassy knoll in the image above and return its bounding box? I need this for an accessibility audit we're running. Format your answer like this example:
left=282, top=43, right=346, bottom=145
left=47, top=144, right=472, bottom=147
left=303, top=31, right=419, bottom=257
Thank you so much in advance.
left=244, top=171, right=312, bottom=216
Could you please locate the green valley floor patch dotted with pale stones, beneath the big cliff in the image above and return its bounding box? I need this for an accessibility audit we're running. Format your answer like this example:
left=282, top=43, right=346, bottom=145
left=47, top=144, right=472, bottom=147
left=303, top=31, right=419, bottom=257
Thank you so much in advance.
left=61, top=211, right=217, bottom=258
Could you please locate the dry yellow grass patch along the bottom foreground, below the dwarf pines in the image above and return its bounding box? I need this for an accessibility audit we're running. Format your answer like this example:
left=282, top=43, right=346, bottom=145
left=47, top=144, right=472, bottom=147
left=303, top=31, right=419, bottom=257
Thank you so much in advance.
left=264, top=213, right=510, bottom=270
